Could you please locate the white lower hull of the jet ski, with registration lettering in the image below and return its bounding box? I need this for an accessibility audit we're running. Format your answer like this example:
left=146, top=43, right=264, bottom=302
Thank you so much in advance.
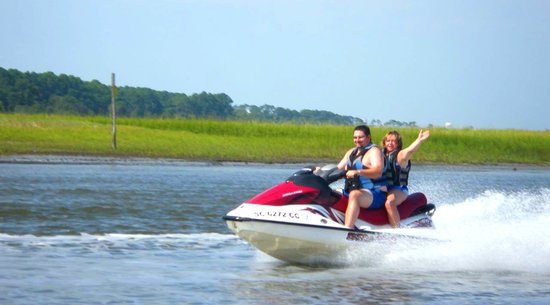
left=224, top=207, right=431, bottom=265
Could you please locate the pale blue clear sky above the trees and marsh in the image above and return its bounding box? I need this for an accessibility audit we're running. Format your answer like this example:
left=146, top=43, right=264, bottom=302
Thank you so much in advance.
left=0, top=0, right=550, bottom=130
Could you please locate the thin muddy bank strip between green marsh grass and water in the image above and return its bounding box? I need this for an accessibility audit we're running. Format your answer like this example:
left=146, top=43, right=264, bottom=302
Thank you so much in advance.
left=0, top=154, right=550, bottom=170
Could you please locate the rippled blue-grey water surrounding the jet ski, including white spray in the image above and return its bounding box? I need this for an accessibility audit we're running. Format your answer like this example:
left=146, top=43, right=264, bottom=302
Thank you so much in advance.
left=0, top=157, right=550, bottom=304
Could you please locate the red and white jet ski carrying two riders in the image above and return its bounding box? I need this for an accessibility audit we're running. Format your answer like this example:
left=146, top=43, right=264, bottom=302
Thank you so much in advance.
left=223, top=165, right=435, bottom=265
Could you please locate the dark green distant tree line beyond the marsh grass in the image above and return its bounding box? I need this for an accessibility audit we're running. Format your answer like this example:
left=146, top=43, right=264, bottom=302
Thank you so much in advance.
left=0, top=67, right=363, bottom=125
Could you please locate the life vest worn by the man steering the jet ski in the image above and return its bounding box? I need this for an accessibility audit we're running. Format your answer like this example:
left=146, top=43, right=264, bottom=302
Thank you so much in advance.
left=344, top=143, right=388, bottom=192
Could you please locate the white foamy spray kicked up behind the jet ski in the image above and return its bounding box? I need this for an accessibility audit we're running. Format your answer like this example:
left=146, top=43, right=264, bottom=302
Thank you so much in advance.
left=347, top=188, right=550, bottom=274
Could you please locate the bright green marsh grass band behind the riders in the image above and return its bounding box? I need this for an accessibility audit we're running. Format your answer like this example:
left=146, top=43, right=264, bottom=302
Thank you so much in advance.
left=0, top=114, right=550, bottom=167
